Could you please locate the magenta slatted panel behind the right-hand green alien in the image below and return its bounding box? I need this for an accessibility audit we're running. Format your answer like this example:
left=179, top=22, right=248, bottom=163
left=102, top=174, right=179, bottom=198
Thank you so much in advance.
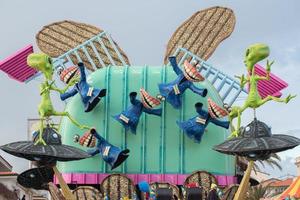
left=248, top=64, right=288, bottom=98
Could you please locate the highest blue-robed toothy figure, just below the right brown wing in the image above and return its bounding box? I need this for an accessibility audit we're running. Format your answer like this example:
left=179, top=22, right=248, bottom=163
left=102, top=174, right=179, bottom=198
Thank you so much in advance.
left=158, top=57, right=207, bottom=109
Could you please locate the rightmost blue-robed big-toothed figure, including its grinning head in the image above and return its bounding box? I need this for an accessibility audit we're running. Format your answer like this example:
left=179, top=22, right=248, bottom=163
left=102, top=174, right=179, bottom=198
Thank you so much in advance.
left=177, top=99, right=229, bottom=143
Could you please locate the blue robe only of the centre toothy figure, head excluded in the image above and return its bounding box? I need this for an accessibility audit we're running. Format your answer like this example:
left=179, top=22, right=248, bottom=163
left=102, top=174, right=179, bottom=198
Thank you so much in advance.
left=113, top=92, right=162, bottom=134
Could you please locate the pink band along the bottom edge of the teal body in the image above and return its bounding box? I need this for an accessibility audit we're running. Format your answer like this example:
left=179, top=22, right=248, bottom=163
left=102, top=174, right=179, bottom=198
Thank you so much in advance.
left=54, top=173, right=237, bottom=186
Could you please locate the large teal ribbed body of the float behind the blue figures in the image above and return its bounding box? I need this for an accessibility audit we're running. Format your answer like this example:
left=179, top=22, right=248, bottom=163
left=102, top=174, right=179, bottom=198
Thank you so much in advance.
left=59, top=66, right=234, bottom=175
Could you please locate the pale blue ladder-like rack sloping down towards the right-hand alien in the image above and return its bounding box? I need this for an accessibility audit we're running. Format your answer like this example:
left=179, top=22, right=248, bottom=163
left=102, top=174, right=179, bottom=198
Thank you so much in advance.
left=174, top=48, right=248, bottom=106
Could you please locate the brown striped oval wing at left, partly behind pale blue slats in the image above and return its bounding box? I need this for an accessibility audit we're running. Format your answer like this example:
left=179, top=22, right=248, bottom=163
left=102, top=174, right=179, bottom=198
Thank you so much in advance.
left=36, top=20, right=130, bottom=71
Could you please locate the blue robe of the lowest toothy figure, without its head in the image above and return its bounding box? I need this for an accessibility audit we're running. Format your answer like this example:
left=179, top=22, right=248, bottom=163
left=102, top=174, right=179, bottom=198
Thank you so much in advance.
left=88, top=129, right=129, bottom=170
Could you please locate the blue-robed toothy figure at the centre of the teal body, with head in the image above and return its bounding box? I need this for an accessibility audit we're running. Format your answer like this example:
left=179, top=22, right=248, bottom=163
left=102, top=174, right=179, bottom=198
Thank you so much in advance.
left=113, top=89, right=162, bottom=134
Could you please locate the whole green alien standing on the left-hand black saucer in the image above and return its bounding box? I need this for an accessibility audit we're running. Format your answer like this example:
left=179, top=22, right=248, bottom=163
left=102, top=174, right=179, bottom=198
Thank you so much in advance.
left=27, top=53, right=90, bottom=145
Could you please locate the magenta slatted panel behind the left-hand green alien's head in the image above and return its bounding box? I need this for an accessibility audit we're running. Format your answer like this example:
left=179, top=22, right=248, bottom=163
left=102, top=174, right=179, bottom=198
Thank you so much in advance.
left=0, top=45, right=38, bottom=82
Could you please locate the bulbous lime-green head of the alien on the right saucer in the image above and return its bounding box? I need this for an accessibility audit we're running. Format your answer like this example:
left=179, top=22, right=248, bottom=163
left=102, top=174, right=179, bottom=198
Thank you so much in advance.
left=244, top=43, right=270, bottom=73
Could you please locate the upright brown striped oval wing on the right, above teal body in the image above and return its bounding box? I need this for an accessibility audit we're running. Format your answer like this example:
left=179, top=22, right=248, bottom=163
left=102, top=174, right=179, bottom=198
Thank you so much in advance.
left=164, top=6, right=235, bottom=64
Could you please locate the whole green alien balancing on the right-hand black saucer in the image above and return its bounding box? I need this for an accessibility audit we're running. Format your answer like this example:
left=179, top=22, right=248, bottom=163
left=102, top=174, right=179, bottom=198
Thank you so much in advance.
left=229, top=43, right=296, bottom=137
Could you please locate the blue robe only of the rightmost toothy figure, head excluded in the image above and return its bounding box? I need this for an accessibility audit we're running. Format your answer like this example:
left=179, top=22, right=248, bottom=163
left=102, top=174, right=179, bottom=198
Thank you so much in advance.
left=176, top=103, right=229, bottom=143
